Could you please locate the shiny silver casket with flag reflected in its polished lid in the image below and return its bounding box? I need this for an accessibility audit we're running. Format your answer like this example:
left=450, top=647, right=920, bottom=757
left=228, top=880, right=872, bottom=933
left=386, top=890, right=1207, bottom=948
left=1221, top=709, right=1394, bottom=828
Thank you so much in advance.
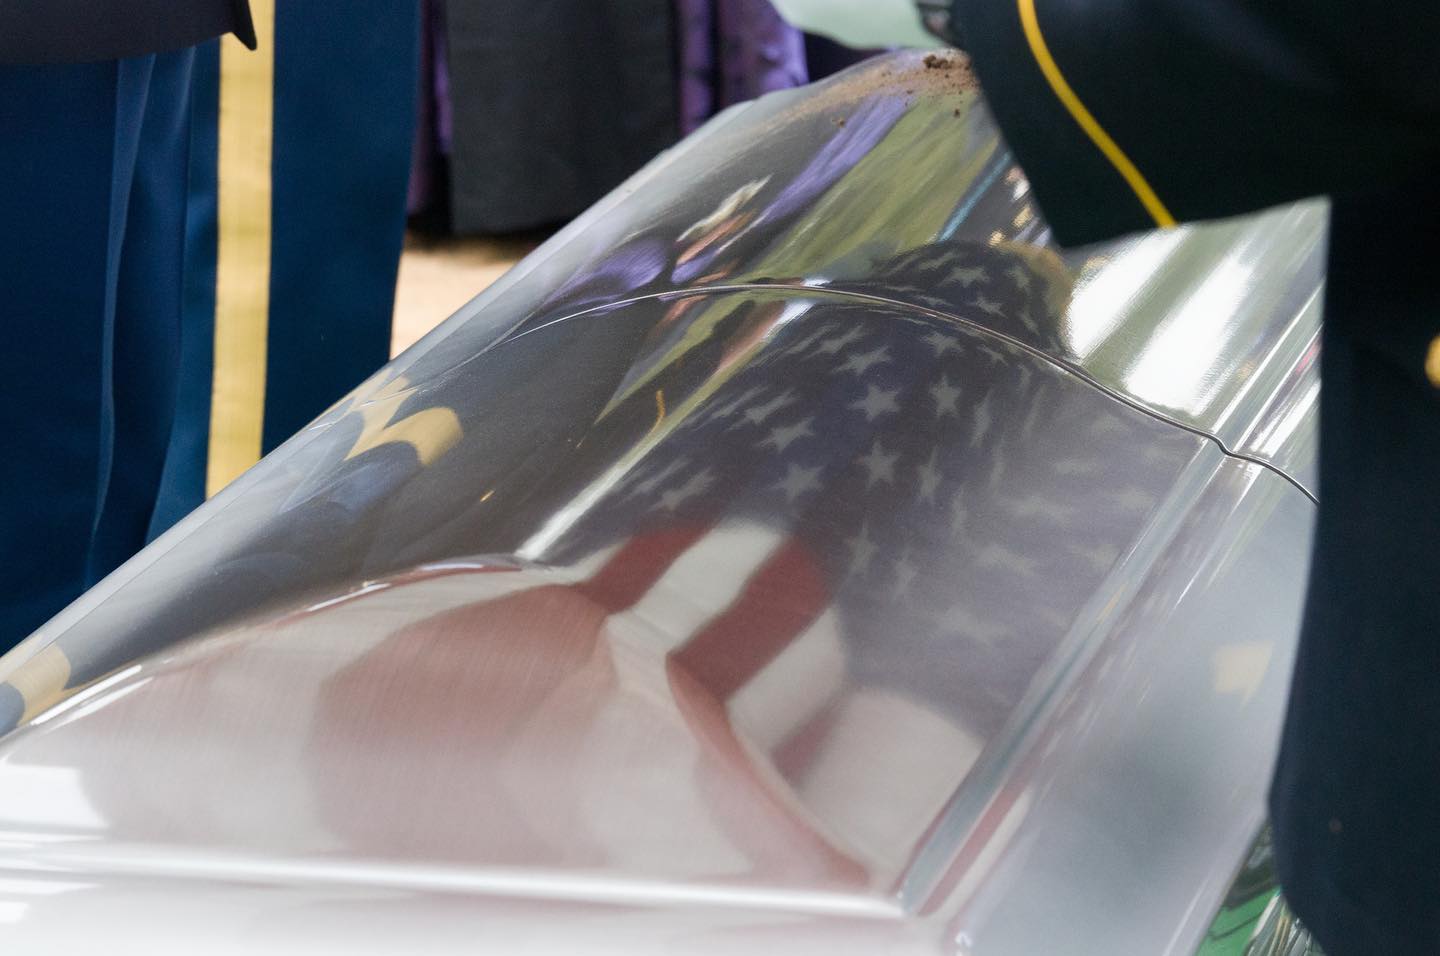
left=0, top=56, right=1320, bottom=956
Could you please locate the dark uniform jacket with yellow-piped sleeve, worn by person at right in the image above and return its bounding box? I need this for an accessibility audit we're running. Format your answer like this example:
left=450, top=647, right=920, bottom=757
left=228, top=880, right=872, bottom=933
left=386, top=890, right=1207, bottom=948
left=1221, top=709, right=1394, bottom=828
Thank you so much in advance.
left=953, top=0, right=1440, bottom=956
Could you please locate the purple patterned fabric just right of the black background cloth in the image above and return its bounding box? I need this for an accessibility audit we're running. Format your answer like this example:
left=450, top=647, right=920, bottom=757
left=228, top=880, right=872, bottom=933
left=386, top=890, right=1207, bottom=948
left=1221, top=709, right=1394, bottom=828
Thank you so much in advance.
left=675, top=0, right=809, bottom=134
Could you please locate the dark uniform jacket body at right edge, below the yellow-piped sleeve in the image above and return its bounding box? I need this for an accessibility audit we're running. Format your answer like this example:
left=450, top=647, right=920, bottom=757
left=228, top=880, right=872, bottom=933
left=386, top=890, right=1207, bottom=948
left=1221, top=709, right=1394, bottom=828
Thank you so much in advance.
left=1270, top=184, right=1440, bottom=956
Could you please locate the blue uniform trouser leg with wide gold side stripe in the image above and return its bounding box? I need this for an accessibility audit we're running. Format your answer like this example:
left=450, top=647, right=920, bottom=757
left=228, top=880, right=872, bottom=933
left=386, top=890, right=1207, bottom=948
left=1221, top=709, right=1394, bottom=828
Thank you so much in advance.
left=157, top=0, right=418, bottom=526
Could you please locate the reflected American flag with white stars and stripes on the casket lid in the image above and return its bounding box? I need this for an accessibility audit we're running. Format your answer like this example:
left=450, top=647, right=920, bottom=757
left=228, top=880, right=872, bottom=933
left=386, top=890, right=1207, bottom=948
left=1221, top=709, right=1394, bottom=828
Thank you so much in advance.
left=391, top=246, right=1197, bottom=871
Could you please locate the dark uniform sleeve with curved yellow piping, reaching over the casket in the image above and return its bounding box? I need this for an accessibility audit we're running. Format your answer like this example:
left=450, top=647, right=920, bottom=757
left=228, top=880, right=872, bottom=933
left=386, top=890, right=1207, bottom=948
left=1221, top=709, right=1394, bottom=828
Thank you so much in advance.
left=955, top=0, right=1440, bottom=245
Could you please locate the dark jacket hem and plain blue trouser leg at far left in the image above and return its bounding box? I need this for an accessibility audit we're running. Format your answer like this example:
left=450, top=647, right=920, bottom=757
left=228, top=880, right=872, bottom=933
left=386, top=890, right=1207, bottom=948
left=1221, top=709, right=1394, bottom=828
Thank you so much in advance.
left=0, top=0, right=253, bottom=651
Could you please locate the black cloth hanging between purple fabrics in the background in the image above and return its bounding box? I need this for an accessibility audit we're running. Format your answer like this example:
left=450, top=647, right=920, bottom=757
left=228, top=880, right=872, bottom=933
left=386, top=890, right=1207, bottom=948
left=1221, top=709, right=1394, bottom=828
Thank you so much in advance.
left=446, top=0, right=678, bottom=232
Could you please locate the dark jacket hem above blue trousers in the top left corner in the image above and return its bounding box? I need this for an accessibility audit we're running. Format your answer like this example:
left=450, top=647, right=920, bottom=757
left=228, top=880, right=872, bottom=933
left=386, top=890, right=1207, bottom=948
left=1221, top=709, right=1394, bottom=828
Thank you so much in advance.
left=0, top=0, right=255, bottom=63
